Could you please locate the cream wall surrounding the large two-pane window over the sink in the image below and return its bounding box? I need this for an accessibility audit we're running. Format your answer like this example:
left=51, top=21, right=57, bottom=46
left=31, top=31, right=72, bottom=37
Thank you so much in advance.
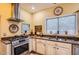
left=33, top=3, right=79, bottom=33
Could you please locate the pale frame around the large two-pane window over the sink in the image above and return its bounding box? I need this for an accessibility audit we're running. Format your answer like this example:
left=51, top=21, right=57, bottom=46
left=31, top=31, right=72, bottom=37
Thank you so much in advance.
left=45, top=14, right=78, bottom=35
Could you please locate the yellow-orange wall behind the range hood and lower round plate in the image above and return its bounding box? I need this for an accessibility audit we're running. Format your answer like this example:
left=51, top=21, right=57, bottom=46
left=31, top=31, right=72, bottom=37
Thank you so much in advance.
left=0, top=3, right=32, bottom=37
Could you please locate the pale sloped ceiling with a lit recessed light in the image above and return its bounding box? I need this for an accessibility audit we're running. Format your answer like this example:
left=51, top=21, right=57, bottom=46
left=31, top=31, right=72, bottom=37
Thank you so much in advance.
left=20, top=3, right=57, bottom=13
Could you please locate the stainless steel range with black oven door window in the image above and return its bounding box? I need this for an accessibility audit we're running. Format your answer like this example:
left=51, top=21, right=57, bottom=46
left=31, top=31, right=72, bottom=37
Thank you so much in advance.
left=12, top=36, right=29, bottom=55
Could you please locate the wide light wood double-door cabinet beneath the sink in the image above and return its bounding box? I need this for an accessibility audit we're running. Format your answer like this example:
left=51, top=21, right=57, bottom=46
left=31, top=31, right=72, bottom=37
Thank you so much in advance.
left=46, top=41, right=72, bottom=55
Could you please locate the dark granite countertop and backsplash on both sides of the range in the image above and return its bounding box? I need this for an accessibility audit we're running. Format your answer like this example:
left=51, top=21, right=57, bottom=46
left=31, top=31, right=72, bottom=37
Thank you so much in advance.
left=1, top=34, right=79, bottom=44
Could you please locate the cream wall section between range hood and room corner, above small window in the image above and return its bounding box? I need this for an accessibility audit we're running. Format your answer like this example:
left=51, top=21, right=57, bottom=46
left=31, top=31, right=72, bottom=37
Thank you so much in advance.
left=20, top=8, right=33, bottom=31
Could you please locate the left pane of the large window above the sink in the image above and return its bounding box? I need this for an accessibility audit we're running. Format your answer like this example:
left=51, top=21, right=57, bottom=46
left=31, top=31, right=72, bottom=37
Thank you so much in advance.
left=46, top=18, right=58, bottom=34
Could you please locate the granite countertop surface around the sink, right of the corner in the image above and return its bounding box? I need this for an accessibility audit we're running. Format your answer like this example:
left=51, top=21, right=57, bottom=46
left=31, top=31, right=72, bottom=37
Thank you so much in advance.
left=32, top=36, right=79, bottom=44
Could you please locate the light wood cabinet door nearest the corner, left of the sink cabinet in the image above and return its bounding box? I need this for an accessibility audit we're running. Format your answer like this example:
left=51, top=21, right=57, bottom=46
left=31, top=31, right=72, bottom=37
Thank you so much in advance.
left=37, top=39, right=45, bottom=54
